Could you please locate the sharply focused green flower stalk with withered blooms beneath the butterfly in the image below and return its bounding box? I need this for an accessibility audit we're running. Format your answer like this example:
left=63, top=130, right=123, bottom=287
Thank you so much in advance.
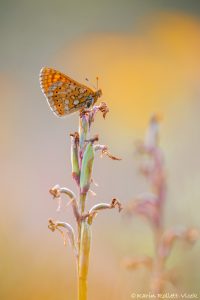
left=49, top=103, right=122, bottom=300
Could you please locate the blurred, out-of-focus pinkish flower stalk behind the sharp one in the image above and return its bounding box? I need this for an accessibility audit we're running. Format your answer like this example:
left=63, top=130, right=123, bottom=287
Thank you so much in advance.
left=125, top=115, right=200, bottom=295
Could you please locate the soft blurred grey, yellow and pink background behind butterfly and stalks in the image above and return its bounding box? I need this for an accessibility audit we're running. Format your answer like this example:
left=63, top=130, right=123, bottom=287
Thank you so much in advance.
left=0, top=0, right=200, bottom=300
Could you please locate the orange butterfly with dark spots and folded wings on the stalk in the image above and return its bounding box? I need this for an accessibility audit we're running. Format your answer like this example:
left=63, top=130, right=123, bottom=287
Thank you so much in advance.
left=40, top=67, right=102, bottom=117
